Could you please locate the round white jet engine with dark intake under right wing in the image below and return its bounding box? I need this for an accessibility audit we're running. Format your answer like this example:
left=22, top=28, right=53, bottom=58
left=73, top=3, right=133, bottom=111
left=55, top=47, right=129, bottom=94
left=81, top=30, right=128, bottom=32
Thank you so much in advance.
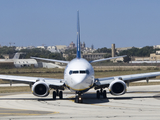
left=109, top=79, right=126, bottom=95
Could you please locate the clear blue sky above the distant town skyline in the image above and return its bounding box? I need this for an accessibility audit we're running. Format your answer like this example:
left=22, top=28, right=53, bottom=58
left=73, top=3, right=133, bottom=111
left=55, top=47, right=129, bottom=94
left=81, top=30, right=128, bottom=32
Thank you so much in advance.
left=0, top=0, right=160, bottom=49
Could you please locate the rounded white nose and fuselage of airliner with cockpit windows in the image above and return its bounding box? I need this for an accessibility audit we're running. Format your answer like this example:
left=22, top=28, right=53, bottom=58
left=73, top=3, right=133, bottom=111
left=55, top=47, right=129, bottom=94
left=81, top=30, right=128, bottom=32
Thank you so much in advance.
left=64, top=58, right=94, bottom=92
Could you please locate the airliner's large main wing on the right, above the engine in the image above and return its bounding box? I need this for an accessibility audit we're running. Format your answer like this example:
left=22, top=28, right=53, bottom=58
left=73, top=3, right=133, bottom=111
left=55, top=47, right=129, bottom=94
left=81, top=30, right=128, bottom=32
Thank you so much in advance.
left=95, top=72, right=160, bottom=87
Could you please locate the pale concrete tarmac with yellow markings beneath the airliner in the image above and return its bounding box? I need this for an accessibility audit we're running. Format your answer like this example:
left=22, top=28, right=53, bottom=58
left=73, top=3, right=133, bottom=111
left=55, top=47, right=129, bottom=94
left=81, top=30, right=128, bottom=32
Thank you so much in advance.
left=0, top=85, right=160, bottom=120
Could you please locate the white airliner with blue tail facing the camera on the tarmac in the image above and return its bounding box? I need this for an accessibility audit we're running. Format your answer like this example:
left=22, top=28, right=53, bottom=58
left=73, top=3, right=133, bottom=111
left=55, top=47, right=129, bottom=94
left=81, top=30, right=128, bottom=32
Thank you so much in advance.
left=0, top=11, right=160, bottom=103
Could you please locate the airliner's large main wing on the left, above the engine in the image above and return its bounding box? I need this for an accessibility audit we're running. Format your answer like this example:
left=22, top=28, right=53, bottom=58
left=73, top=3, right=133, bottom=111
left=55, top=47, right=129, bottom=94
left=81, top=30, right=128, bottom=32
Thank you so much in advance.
left=0, top=75, right=64, bottom=88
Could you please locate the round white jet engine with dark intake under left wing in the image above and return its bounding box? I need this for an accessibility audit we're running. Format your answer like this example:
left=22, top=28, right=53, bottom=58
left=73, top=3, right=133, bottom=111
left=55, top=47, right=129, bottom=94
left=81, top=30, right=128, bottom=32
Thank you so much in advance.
left=32, top=81, right=49, bottom=97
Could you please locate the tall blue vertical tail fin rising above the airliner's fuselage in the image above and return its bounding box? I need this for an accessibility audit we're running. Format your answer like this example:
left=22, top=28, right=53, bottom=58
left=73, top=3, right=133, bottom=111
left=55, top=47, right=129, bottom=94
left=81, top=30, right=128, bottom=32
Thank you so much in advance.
left=77, top=11, right=81, bottom=59
